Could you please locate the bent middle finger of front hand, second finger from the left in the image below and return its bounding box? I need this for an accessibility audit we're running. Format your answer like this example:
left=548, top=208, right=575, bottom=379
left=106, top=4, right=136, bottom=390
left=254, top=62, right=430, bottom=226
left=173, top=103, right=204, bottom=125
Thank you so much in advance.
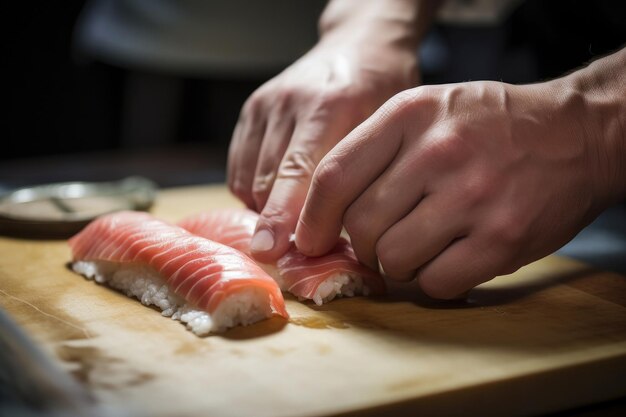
left=343, top=150, right=424, bottom=269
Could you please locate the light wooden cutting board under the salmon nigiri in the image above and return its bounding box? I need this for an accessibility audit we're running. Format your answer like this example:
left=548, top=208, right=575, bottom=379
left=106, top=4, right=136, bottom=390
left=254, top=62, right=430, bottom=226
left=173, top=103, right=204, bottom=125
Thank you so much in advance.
left=0, top=186, right=626, bottom=417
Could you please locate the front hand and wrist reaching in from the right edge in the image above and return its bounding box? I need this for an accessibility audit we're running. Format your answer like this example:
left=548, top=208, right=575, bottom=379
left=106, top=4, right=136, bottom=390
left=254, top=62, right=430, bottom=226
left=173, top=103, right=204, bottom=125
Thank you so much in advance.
left=296, top=48, right=626, bottom=299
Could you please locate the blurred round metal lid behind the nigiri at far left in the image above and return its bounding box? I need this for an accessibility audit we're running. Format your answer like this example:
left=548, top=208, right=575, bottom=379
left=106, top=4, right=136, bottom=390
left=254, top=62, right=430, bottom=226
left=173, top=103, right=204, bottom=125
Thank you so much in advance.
left=0, top=177, right=157, bottom=238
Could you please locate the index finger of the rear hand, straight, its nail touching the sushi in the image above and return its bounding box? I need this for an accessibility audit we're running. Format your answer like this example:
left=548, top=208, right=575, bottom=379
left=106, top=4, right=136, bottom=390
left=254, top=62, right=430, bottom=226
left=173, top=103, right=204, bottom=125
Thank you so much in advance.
left=250, top=123, right=334, bottom=263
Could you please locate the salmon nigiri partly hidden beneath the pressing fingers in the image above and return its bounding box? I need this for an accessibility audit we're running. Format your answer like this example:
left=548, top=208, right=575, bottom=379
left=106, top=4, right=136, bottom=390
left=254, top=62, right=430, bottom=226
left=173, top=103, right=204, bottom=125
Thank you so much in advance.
left=173, top=209, right=385, bottom=305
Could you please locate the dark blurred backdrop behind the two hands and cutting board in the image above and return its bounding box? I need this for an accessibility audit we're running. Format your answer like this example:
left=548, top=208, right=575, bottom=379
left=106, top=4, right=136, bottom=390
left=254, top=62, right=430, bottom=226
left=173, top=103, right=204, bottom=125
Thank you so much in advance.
left=0, top=0, right=626, bottom=269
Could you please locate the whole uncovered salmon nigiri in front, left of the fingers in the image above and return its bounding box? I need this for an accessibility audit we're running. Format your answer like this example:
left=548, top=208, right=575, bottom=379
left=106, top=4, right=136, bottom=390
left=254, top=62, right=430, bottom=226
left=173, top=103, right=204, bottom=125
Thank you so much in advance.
left=69, top=211, right=288, bottom=335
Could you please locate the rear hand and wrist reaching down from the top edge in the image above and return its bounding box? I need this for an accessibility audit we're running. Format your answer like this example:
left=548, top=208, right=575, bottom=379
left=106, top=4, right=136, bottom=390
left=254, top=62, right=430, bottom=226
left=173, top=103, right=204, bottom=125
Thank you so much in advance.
left=228, top=0, right=439, bottom=262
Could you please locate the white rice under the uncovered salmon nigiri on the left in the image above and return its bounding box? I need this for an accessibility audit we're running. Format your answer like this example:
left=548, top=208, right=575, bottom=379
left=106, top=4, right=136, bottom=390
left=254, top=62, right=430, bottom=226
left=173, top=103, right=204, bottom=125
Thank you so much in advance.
left=72, top=261, right=272, bottom=336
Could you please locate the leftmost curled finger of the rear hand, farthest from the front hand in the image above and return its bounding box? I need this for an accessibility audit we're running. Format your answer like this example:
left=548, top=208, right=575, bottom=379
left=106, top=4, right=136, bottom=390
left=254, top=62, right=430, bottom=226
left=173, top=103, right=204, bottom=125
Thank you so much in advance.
left=228, top=98, right=266, bottom=209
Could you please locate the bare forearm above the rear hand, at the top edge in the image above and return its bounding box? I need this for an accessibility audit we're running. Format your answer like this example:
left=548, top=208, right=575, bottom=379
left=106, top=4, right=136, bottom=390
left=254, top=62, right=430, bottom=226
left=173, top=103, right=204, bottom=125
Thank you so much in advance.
left=319, top=0, right=442, bottom=51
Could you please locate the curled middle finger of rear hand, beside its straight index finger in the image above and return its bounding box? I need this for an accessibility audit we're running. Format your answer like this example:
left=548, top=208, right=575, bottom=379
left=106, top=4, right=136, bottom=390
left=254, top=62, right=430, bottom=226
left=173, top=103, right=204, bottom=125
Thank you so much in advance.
left=252, top=114, right=295, bottom=212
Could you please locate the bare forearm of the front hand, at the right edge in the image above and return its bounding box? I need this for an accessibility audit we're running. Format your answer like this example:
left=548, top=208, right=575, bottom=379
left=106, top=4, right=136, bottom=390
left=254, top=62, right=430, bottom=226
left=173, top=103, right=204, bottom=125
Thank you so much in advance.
left=563, top=48, right=626, bottom=202
